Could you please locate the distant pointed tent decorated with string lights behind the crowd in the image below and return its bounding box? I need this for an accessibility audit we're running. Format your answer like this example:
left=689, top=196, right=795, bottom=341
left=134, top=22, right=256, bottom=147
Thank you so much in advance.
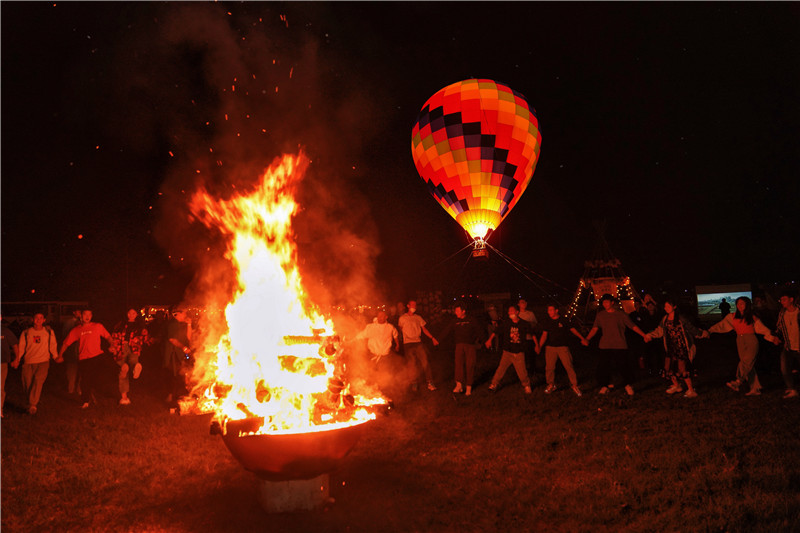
left=567, top=220, right=641, bottom=320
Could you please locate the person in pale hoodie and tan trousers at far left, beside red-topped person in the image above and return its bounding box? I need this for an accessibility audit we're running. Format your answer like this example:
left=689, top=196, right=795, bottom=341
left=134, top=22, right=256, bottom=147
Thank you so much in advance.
left=15, top=313, right=58, bottom=415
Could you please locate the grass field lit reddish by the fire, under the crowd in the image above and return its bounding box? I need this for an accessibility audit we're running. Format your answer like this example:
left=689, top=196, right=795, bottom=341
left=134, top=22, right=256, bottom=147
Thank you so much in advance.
left=1, top=336, right=800, bottom=532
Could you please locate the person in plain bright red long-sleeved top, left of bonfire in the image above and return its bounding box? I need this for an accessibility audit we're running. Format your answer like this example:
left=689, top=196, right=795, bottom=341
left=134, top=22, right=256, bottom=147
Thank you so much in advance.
left=56, top=309, right=111, bottom=409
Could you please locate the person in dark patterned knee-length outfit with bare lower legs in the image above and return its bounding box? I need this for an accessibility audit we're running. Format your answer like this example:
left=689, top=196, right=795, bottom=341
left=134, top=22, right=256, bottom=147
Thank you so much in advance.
left=644, top=298, right=703, bottom=398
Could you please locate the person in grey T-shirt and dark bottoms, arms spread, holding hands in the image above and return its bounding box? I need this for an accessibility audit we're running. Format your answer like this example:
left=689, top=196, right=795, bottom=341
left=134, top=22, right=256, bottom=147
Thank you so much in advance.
left=582, top=294, right=644, bottom=396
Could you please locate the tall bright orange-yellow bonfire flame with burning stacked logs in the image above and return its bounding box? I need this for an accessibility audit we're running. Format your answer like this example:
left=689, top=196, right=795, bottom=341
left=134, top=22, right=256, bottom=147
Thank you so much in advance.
left=184, top=153, right=385, bottom=433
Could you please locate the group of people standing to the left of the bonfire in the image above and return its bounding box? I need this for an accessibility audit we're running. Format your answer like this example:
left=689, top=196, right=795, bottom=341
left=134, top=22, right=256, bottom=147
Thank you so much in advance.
left=0, top=307, right=192, bottom=415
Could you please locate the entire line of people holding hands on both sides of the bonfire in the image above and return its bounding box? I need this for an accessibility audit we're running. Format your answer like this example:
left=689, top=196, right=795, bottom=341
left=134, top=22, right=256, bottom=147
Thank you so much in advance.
left=2, top=288, right=800, bottom=415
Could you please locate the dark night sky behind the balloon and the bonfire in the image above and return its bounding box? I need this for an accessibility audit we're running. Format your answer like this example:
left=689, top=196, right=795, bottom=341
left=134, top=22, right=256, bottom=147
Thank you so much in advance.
left=1, top=2, right=800, bottom=316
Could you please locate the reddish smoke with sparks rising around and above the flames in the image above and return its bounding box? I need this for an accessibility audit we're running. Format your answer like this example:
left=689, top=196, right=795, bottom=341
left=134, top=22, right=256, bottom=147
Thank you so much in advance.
left=105, top=3, right=388, bottom=308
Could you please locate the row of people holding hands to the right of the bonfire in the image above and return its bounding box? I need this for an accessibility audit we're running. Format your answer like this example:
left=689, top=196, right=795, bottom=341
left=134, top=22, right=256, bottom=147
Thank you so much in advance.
left=359, top=288, right=800, bottom=399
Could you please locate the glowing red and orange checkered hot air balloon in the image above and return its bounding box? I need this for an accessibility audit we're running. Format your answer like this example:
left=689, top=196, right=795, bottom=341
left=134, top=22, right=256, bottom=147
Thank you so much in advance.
left=411, top=79, right=542, bottom=255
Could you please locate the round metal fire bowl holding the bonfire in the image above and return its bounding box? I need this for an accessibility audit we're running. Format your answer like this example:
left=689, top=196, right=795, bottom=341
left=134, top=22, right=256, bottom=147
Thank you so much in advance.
left=222, top=420, right=369, bottom=481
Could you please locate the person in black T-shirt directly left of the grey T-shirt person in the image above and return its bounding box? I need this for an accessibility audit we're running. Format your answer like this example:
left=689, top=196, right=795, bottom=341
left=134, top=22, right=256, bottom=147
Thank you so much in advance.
left=536, top=304, right=583, bottom=397
